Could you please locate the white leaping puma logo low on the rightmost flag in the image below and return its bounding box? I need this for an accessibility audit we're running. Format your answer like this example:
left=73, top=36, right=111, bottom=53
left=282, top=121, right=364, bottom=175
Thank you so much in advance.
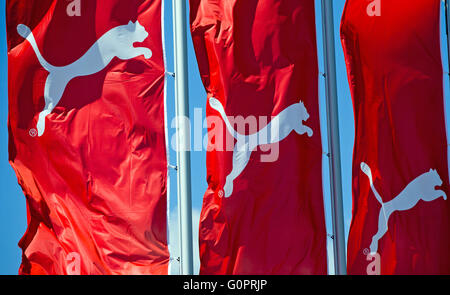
left=361, top=162, right=447, bottom=253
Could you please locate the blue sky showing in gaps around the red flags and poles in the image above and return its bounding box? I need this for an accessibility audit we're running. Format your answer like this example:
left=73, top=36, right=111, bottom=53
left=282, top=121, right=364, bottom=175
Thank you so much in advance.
left=0, top=0, right=450, bottom=274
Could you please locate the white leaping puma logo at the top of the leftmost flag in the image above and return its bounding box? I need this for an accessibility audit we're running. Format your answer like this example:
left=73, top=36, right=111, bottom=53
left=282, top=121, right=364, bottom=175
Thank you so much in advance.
left=17, top=21, right=152, bottom=136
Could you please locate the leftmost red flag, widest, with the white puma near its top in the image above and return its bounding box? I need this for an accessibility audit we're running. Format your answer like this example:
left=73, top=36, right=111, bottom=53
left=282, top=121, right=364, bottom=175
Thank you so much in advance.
left=7, top=0, right=169, bottom=274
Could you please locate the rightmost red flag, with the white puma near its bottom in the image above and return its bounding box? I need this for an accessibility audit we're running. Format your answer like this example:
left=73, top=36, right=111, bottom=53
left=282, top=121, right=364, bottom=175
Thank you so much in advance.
left=341, top=0, right=450, bottom=274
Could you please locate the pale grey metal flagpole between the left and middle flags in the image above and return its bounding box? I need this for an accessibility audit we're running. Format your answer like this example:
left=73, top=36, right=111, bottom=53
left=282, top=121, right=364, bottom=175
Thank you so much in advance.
left=172, top=0, right=194, bottom=275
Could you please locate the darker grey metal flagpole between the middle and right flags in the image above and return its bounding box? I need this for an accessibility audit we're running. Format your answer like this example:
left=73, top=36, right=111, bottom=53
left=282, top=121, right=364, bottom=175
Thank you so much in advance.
left=322, top=0, right=347, bottom=275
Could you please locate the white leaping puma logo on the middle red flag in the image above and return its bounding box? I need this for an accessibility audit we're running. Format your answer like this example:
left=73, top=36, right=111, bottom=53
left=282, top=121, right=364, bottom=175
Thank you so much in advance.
left=209, top=97, right=313, bottom=198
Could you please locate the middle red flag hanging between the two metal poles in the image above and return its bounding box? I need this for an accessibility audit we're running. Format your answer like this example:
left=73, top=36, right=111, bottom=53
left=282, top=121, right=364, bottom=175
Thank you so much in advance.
left=190, top=0, right=327, bottom=274
